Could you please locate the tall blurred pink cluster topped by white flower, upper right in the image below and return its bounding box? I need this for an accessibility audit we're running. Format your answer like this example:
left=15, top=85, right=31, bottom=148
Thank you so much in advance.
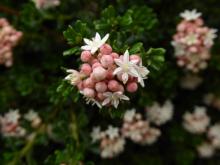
left=172, top=10, right=217, bottom=72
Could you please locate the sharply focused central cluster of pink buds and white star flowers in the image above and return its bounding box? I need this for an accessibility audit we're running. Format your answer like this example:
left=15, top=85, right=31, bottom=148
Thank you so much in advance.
left=65, top=33, right=149, bottom=108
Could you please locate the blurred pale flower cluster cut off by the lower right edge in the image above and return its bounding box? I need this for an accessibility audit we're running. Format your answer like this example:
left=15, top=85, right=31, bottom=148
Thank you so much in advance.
left=208, top=124, right=220, bottom=148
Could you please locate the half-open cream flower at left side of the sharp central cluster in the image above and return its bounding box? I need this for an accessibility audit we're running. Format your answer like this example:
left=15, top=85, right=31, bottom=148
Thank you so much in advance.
left=65, top=69, right=85, bottom=85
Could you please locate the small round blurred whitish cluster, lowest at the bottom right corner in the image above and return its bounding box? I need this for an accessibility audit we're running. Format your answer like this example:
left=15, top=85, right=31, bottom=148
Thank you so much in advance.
left=197, top=142, right=215, bottom=158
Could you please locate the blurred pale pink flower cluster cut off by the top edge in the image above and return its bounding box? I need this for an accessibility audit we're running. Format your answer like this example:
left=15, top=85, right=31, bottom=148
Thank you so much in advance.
left=32, top=0, right=60, bottom=9
